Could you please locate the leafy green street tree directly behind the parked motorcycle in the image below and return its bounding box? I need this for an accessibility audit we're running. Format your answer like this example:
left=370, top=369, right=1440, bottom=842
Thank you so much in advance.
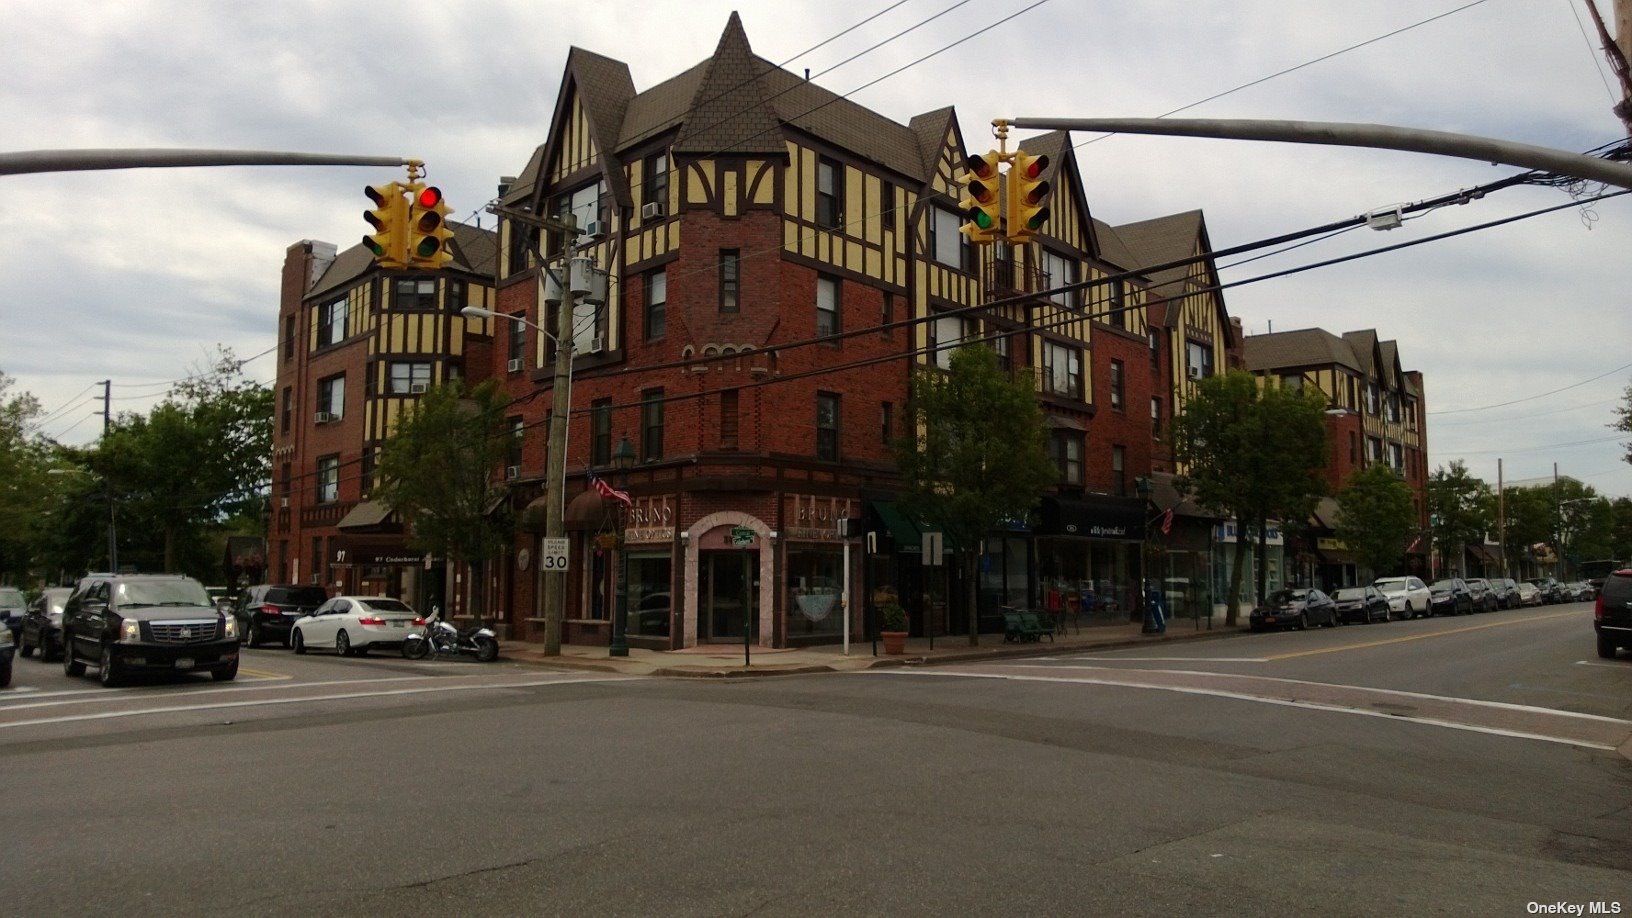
left=375, top=379, right=515, bottom=627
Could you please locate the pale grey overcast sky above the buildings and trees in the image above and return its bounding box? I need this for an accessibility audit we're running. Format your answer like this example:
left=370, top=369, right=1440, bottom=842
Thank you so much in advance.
left=0, top=0, right=1632, bottom=497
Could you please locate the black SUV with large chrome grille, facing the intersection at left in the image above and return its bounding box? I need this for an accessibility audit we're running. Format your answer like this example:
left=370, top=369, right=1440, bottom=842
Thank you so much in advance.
left=62, top=573, right=238, bottom=686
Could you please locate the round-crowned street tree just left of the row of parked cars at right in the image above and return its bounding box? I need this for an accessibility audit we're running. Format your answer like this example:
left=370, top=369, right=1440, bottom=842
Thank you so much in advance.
left=1173, top=371, right=1327, bottom=626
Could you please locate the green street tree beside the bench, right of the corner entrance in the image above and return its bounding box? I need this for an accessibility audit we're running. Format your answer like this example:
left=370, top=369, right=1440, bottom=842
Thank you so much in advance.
left=896, top=345, right=1059, bottom=644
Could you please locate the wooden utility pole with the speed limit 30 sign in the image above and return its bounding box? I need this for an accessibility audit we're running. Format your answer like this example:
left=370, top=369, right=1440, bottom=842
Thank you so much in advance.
left=490, top=207, right=578, bottom=657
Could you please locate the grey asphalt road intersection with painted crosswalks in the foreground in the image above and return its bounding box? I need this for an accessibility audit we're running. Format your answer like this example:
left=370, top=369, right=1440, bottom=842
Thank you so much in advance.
left=0, top=606, right=1632, bottom=915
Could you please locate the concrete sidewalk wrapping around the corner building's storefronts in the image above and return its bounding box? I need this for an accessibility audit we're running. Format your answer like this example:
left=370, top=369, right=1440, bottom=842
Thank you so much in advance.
left=499, top=621, right=1247, bottom=678
